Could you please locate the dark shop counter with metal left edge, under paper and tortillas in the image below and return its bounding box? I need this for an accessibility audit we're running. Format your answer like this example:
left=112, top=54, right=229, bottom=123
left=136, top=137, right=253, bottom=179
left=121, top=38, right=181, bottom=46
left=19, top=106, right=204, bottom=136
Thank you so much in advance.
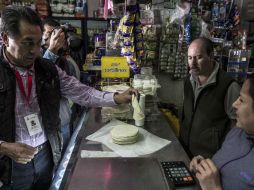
left=50, top=108, right=200, bottom=190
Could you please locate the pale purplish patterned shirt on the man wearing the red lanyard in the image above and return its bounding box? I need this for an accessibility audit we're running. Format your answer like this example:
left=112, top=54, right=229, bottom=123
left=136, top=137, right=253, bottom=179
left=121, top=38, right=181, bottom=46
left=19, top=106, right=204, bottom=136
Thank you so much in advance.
left=0, top=54, right=116, bottom=147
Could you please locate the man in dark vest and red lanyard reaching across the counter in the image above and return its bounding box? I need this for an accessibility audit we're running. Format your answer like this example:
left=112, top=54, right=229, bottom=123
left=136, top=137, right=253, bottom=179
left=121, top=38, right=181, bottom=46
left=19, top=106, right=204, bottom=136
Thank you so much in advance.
left=0, top=6, right=137, bottom=190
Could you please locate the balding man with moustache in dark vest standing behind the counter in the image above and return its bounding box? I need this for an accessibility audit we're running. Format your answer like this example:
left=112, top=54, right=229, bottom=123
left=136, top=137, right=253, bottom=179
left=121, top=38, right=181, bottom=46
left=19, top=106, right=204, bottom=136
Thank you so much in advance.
left=180, top=38, right=240, bottom=157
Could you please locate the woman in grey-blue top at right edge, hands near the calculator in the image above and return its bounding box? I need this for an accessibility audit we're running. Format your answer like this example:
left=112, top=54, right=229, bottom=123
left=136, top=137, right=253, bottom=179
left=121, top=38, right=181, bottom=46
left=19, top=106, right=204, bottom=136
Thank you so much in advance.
left=190, top=74, right=254, bottom=190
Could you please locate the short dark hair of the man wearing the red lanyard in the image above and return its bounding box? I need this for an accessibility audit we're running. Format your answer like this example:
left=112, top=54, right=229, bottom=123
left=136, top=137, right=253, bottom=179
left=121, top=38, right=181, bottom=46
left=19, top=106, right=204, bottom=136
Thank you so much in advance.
left=1, top=6, right=42, bottom=38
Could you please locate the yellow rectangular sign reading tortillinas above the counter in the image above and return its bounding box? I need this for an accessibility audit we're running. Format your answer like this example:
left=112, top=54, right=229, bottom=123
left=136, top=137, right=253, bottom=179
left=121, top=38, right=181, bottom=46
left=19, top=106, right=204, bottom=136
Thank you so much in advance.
left=101, top=56, right=130, bottom=78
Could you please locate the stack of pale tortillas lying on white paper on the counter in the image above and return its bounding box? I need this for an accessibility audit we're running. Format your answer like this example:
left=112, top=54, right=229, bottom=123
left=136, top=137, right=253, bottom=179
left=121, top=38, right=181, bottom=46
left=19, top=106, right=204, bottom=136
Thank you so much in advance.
left=110, top=124, right=138, bottom=145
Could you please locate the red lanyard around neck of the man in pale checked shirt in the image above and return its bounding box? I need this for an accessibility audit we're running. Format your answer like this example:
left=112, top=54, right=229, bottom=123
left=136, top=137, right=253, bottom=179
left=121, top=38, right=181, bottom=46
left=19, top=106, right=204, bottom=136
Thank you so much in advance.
left=15, top=71, right=33, bottom=105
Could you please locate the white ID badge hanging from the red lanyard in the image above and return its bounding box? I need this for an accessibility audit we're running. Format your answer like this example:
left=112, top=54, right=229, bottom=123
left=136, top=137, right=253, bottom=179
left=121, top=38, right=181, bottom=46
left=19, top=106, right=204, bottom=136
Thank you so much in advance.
left=24, top=114, right=42, bottom=136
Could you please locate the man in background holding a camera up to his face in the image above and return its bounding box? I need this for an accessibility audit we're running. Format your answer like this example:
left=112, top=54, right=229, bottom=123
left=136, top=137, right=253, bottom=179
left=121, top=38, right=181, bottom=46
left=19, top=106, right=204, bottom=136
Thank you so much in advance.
left=42, top=18, right=80, bottom=154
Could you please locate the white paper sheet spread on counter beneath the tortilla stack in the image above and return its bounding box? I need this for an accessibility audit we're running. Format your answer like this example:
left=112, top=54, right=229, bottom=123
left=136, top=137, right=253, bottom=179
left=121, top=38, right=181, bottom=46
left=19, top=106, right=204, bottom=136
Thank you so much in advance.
left=86, top=120, right=171, bottom=157
